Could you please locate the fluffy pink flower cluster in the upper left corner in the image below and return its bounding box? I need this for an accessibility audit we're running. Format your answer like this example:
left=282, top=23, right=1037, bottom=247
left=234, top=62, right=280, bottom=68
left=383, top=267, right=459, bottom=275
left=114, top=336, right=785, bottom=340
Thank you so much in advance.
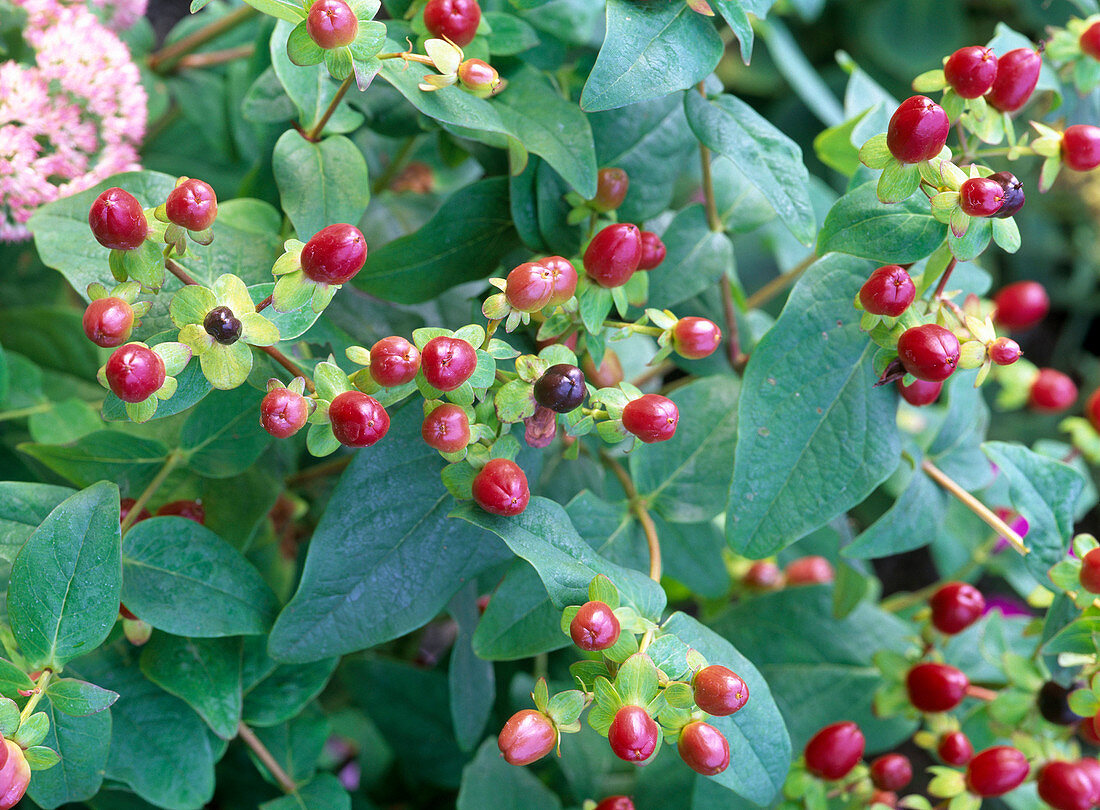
left=0, top=0, right=146, bottom=240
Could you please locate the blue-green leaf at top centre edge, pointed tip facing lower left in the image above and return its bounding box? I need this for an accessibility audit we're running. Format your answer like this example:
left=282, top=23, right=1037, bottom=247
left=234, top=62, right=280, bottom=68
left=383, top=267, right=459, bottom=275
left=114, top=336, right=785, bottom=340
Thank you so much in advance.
left=581, top=0, right=723, bottom=111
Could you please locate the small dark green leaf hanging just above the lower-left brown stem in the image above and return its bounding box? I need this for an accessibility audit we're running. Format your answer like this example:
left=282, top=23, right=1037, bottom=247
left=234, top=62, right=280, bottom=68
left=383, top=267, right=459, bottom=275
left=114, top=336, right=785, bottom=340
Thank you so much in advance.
left=141, top=633, right=242, bottom=740
